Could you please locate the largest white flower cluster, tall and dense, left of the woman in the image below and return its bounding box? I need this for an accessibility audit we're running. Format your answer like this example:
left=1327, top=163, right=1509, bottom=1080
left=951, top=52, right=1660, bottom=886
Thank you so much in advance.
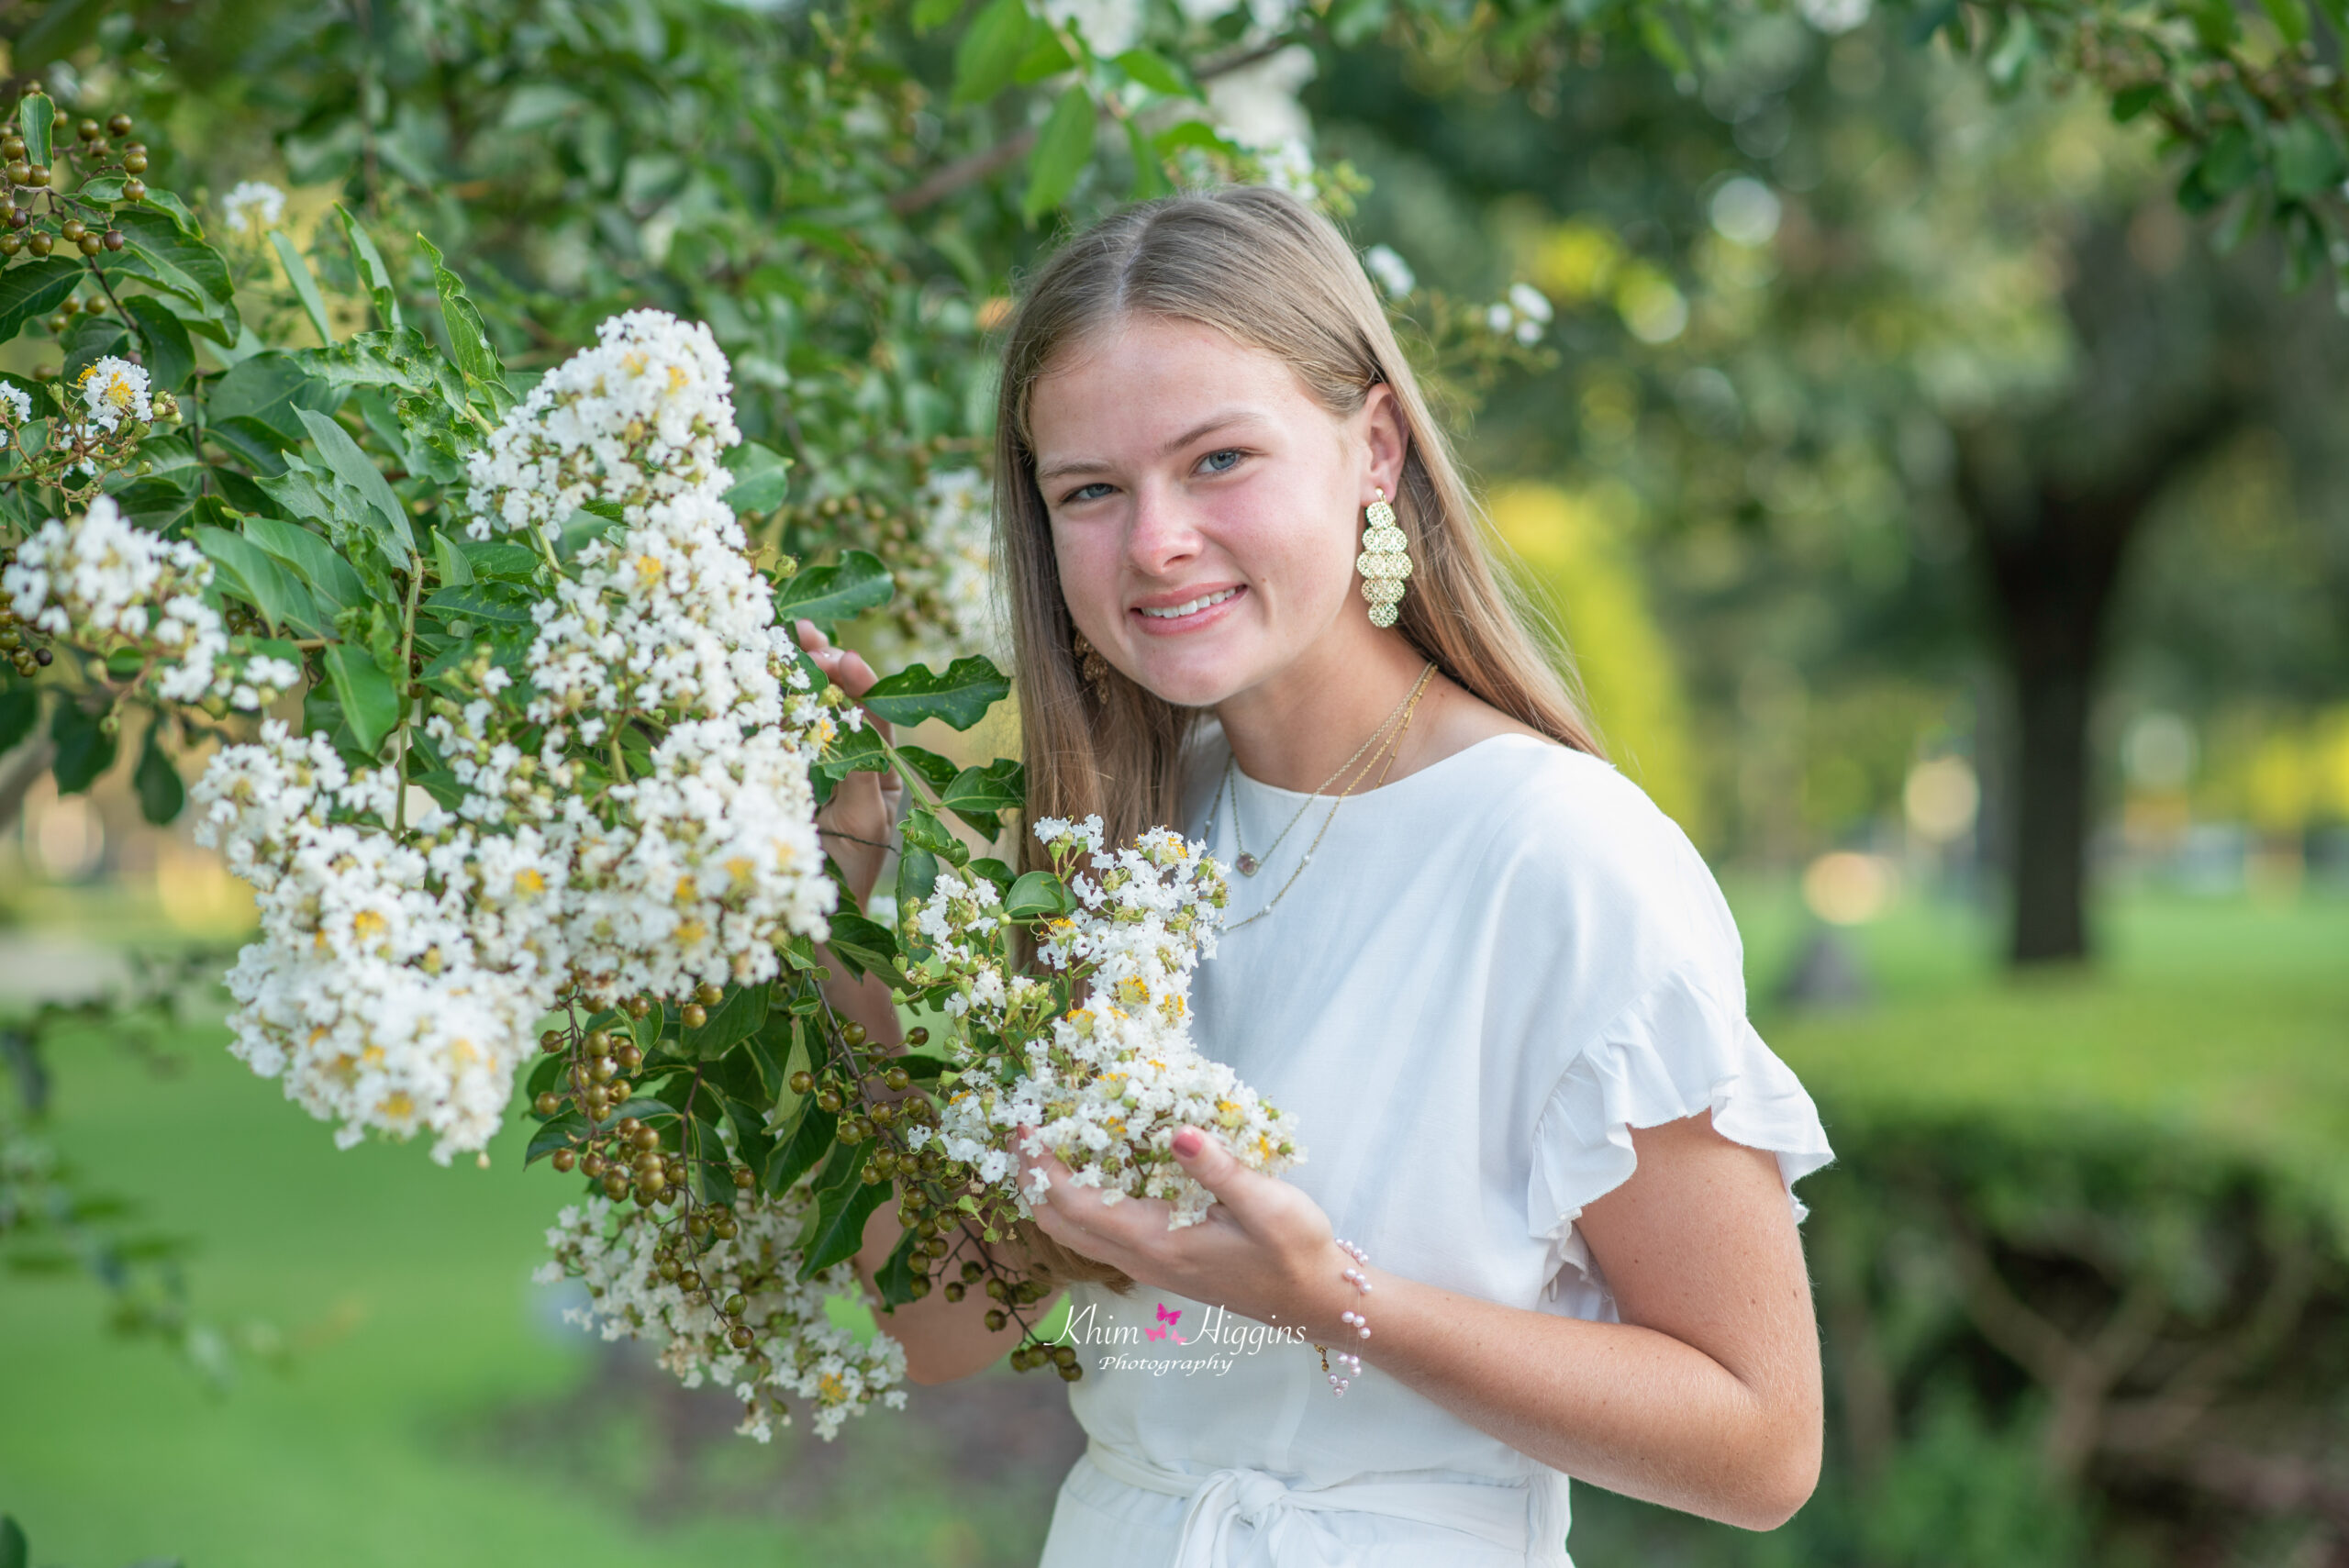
left=197, top=312, right=836, bottom=1160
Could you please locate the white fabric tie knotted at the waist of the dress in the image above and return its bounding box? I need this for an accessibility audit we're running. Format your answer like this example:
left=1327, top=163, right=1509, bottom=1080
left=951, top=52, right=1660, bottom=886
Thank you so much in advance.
left=1085, top=1439, right=1574, bottom=1568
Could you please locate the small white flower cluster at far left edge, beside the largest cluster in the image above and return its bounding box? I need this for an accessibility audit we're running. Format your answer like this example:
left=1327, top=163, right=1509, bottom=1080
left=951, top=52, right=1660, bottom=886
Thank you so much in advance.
left=0, top=495, right=264, bottom=709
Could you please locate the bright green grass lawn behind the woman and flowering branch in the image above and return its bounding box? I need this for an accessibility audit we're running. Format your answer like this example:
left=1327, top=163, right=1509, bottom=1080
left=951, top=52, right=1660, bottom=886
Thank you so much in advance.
left=0, top=890, right=2349, bottom=1568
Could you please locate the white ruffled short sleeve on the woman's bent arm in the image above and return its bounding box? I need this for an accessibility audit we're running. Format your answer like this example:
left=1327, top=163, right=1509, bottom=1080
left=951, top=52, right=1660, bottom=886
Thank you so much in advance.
left=1527, top=962, right=1834, bottom=1315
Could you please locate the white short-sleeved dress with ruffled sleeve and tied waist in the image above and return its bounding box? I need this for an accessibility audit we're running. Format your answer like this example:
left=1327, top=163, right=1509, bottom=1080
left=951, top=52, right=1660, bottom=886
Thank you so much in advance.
left=1041, top=726, right=1830, bottom=1568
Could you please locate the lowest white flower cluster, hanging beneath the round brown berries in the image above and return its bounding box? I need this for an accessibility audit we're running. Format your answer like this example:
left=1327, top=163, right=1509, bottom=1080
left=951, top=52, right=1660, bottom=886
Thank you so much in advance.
left=536, top=1185, right=905, bottom=1443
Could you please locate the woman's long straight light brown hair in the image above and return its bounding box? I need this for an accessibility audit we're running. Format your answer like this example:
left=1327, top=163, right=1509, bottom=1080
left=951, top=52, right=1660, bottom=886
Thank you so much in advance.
left=996, top=185, right=1604, bottom=863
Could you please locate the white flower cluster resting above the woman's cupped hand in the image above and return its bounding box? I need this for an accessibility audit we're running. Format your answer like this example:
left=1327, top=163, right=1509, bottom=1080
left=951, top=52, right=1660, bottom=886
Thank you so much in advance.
left=907, top=817, right=1304, bottom=1228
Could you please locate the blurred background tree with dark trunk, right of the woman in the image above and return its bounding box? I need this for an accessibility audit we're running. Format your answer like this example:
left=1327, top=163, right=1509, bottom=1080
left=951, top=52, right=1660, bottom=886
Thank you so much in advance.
left=1316, top=17, right=2349, bottom=962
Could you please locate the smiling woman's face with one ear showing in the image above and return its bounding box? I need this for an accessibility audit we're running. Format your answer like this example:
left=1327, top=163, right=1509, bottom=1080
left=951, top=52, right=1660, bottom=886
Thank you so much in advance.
left=1029, top=315, right=1402, bottom=706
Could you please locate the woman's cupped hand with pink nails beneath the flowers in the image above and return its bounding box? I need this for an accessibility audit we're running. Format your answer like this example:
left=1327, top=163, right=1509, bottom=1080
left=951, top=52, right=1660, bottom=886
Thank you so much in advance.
left=1015, top=1127, right=1351, bottom=1336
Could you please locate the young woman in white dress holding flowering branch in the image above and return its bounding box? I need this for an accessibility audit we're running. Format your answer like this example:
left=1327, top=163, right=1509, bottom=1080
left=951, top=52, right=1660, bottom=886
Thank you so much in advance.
left=804, top=190, right=1830, bottom=1568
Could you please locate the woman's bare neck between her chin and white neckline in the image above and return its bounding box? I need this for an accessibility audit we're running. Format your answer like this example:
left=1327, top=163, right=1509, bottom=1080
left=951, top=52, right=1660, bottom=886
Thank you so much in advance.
left=1215, top=631, right=1428, bottom=791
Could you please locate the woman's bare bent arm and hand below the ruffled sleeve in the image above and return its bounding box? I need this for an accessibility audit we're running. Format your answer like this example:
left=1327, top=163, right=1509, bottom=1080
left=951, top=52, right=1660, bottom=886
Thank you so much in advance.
left=1019, top=1115, right=1823, bottom=1530
